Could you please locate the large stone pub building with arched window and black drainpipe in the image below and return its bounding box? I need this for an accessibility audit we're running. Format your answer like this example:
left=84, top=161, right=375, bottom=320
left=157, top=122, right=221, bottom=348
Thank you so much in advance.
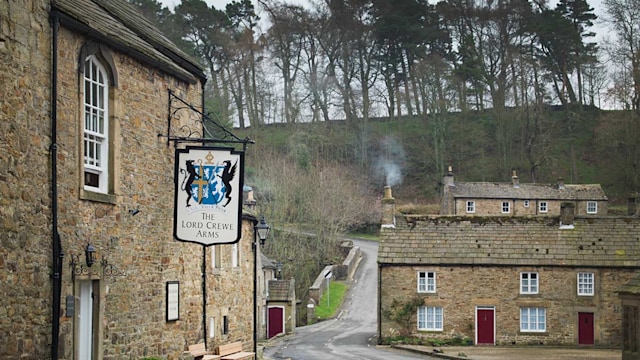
left=0, top=0, right=259, bottom=360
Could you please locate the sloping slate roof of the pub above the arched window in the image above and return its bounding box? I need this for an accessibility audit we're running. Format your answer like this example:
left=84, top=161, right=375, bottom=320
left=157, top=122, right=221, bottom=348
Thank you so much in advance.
left=51, top=0, right=206, bottom=83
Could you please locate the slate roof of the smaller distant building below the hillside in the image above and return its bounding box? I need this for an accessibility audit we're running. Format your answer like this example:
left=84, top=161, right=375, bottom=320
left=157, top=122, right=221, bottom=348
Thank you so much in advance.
left=448, top=182, right=607, bottom=201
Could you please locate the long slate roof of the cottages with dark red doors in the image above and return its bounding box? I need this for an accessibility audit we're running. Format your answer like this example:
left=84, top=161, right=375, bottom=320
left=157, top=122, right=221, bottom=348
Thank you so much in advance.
left=378, top=216, right=640, bottom=268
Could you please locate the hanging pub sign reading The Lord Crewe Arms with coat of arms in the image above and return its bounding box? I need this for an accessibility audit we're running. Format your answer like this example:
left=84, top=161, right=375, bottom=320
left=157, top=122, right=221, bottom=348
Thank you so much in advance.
left=173, top=147, right=244, bottom=246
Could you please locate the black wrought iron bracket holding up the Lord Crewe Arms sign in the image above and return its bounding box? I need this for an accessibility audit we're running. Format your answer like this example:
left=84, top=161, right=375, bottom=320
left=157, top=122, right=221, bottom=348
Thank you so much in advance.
left=158, top=89, right=255, bottom=150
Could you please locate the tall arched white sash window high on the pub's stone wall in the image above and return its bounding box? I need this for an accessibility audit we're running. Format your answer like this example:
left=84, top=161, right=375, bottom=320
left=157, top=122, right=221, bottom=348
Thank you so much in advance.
left=83, top=55, right=109, bottom=193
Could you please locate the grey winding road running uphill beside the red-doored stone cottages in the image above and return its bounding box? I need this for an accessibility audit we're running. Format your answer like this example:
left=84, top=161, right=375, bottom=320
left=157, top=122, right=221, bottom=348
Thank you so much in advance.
left=264, top=240, right=429, bottom=360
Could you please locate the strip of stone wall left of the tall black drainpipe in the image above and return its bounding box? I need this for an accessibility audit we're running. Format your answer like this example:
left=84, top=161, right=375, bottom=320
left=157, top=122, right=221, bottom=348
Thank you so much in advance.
left=0, top=0, right=59, bottom=360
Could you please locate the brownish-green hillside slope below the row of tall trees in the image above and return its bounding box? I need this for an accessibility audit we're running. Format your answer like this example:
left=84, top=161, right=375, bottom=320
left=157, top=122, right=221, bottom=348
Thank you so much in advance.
left=236, top=107, right=640, bottom=204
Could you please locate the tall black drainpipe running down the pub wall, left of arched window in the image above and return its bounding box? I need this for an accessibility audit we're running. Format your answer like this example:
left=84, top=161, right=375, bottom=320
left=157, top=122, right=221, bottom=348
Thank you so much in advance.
left=49, top=11, right=64, bottom=360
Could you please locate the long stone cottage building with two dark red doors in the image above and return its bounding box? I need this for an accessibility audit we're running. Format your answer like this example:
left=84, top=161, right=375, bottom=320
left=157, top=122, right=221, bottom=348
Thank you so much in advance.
left=378, top=187, right=640, bottom=346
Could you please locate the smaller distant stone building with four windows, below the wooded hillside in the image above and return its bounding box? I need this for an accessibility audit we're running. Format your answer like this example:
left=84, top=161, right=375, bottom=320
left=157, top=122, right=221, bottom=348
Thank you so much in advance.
left=440, top=167, right=608, bottom=216
